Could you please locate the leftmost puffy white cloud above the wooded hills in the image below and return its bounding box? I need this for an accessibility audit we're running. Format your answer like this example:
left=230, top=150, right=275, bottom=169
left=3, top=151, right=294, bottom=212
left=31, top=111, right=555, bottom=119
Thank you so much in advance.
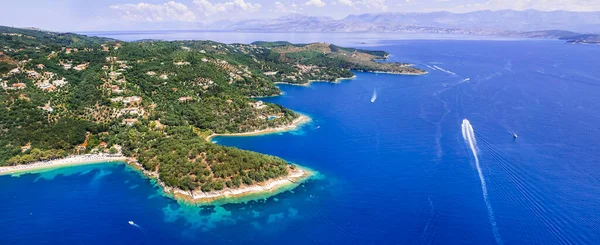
left=110, top=1, right=196, bottom=22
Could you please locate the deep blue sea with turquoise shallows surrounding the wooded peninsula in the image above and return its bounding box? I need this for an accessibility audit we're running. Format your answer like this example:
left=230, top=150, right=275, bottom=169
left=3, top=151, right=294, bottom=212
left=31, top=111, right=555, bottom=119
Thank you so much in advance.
left=0, top=34, right=600, bottom=245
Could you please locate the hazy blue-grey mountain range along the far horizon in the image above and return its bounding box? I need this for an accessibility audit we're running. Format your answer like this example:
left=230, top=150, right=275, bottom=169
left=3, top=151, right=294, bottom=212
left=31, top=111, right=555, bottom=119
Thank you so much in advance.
left=219, top=10, right=600, bottom=38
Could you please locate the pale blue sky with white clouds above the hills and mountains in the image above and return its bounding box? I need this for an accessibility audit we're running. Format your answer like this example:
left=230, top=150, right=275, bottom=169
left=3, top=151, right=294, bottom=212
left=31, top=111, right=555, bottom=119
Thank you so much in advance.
left=0, top=0, right=600, bottom=31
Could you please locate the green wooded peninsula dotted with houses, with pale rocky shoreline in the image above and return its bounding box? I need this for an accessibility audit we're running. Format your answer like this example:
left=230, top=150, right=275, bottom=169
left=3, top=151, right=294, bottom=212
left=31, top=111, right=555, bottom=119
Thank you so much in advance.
left=0, top=27, right=426, bottom=203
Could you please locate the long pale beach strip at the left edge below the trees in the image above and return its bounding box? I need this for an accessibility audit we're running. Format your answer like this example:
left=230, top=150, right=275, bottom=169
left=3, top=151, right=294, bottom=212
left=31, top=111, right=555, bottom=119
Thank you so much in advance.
left=0, top=154, right=127, bottom=175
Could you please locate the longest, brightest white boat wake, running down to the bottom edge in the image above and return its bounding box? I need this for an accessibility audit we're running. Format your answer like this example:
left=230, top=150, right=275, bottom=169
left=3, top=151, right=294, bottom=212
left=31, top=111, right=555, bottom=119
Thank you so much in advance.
left=462, top=119, right=504, bottom=244
